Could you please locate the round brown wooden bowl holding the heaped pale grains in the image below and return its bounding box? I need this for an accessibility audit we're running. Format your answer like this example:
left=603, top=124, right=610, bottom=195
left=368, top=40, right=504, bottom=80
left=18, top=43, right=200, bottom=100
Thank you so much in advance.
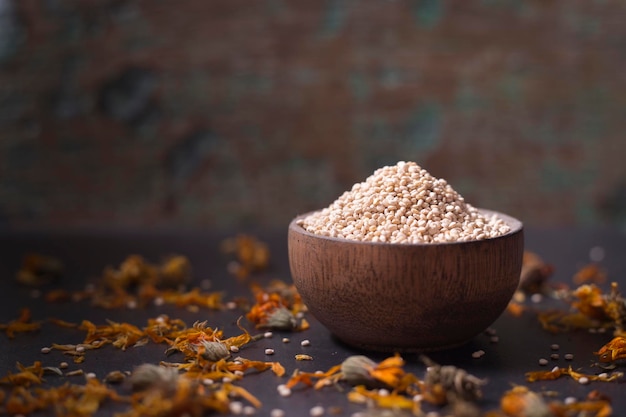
left=288, top=209, right=524, bottom=352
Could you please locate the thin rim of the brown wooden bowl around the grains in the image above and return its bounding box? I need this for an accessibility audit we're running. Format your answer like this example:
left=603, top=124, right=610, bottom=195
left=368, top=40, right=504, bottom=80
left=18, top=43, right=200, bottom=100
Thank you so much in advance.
left=289, top=207, right=524, bottom=247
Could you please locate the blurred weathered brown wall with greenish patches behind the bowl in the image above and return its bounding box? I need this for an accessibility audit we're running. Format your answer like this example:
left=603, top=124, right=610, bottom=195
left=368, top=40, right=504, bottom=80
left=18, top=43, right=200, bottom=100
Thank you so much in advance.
left=0, top=0, right=626, bottom=228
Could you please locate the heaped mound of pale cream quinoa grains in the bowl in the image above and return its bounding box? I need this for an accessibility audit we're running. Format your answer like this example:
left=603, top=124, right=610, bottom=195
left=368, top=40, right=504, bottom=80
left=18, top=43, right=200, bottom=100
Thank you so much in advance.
left=298, top=161, right=510, bottom=243
